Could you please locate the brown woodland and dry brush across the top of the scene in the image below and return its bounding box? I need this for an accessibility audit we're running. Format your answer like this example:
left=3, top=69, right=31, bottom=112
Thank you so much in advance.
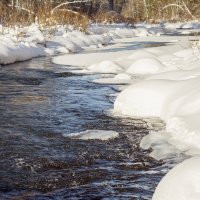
left=0, top=0, right=200, bottom=30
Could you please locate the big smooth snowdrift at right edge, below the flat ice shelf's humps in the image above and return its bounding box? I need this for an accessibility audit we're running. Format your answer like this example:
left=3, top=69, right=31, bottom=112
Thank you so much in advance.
left=114, top=76, right=200, bottom=158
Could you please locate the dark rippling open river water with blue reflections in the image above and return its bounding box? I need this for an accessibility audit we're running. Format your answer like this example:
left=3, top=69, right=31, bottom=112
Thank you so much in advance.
left=0, top=52, right=183, bottom=200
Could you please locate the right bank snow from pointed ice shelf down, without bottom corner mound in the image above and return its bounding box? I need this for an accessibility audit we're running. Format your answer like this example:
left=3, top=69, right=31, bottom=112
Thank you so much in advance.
left=53, top=26, right=200, bottom=159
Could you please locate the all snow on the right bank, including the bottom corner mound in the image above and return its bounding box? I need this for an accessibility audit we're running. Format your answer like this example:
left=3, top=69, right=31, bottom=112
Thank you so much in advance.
left=53, top=23, right=200, bottom=200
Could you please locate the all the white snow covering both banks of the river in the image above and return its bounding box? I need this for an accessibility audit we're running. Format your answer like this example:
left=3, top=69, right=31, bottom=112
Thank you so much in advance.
left=0, top=22, right=200, bottom=200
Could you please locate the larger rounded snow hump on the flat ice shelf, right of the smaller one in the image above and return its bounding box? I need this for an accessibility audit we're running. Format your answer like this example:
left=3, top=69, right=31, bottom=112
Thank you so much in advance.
left=126, top=58, right=165, bottom=75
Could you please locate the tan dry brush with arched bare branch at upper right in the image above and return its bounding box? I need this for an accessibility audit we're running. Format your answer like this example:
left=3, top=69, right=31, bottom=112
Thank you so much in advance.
left=121, top=0, right=200, bottom=22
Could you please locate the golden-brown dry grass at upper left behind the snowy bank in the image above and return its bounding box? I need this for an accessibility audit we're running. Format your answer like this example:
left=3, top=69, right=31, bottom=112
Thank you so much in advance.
left=0, top=3, right=89, bottom=31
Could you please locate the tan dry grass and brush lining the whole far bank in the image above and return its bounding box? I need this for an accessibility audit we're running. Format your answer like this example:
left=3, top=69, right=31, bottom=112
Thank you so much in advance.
left=0, top=0, right=200, bottom=31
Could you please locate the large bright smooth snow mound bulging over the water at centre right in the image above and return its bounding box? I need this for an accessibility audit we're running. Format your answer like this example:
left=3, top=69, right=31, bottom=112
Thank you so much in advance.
left=114, top=80, right=174, bottom=117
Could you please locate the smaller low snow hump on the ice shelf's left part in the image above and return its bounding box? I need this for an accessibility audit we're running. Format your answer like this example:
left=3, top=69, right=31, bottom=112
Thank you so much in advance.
left=88, top=61, right=121, bottom=74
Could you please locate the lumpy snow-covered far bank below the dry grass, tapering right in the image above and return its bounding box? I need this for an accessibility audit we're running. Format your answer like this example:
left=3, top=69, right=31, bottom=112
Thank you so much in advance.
left=0, top=23, right=199, bottom=64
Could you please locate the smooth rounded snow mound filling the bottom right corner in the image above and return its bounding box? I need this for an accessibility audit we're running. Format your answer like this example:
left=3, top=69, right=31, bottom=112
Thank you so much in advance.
left=152, top=157, right=200, bottom=200
